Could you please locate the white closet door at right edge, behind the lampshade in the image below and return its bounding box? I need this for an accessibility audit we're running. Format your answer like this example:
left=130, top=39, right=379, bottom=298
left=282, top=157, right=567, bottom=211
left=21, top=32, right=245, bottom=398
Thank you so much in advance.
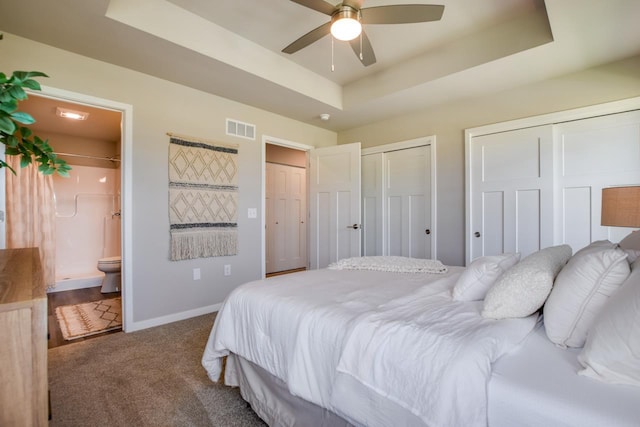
left=555, top=111, right=640, bottom=251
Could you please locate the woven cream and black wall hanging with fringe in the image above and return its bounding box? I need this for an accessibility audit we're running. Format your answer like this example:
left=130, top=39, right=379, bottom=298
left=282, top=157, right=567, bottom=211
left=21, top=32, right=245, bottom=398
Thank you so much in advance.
left=169, top=134, right=238, bottom=261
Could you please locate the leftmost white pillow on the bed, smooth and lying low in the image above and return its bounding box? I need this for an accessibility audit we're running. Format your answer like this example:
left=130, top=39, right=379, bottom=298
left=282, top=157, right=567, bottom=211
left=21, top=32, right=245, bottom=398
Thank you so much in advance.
left=453, top=253, right=520, bottom=301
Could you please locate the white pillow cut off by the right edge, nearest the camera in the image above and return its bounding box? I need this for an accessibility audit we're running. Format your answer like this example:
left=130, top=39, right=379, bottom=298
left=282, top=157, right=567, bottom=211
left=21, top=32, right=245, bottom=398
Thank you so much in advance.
left=578, top=260, right=640, bottom=386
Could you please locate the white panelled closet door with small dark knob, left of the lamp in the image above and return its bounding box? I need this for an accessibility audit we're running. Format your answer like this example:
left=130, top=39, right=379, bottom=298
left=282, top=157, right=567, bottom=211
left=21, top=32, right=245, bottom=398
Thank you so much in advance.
left=467, top=126, right=553, bottom=263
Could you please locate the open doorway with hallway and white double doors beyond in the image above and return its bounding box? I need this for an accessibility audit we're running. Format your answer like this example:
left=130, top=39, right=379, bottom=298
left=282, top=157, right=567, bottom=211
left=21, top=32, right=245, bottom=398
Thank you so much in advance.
left=264, top=143, right=308, bottom=275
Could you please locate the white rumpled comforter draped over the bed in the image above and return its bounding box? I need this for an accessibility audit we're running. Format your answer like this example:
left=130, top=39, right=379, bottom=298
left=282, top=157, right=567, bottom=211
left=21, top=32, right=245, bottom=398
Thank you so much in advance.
left=202, top=267, right=536, bottom=426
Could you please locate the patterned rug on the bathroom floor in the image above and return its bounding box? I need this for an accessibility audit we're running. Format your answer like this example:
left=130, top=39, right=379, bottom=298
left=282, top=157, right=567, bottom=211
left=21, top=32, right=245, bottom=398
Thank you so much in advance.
left=56, top=298, right=122, bottom=340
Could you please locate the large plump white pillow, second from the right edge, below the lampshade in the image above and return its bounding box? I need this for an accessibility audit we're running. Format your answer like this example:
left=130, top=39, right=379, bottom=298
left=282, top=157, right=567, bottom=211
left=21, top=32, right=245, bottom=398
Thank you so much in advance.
left=544, top=241, right=631, bottom=347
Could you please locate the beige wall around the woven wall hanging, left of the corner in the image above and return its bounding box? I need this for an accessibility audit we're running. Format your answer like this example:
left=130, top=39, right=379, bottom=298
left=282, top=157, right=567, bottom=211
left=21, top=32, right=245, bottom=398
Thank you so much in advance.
left=0, top=33, right=337, bottom=325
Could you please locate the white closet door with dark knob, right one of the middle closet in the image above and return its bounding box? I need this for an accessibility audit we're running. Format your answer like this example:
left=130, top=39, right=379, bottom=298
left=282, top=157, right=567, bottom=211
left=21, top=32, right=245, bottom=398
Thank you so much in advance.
left=384, top=146, right=431, bottom=258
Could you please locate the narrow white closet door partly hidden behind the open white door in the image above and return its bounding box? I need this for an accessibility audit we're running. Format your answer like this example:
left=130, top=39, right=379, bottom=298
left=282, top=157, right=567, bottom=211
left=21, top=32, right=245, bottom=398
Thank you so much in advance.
left=362, top=153, right=384, bottom=256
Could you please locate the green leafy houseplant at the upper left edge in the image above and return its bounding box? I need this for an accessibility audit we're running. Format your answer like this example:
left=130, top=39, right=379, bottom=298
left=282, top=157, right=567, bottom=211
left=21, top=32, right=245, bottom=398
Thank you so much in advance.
left=0, top=34, right=71, bottom=176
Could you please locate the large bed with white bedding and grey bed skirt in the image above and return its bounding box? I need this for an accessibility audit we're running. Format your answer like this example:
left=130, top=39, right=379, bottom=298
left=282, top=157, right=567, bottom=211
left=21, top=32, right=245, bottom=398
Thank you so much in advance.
left=202, top=243, right=640, bottom=426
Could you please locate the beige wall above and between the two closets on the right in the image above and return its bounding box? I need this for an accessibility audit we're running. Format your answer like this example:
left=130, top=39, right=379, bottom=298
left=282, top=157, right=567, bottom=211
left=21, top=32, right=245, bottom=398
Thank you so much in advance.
left=338, top=56, right=640, bottom=265
